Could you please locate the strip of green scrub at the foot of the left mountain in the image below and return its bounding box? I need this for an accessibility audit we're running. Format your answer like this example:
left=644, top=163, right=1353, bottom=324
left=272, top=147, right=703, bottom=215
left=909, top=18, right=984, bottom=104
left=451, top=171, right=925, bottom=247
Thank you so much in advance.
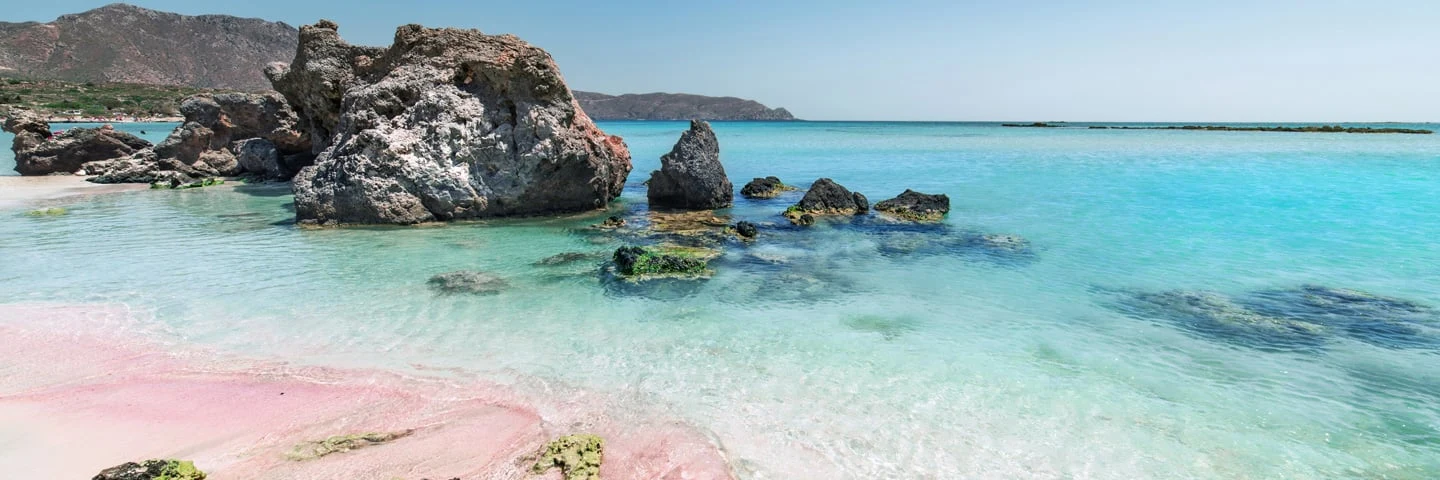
left=0, top=78, right=224, bottom=117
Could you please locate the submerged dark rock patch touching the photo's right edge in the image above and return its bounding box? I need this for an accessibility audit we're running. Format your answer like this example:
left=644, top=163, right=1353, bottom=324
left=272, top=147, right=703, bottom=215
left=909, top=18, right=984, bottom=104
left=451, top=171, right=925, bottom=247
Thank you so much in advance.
left=1241, top=285, right=1440, bottom=349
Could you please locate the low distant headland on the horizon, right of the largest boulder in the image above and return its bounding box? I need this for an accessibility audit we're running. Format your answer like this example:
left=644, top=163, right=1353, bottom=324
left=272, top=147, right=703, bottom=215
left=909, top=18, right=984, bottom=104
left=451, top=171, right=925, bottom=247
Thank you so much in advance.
left=575, top=91, right=795, bottom=120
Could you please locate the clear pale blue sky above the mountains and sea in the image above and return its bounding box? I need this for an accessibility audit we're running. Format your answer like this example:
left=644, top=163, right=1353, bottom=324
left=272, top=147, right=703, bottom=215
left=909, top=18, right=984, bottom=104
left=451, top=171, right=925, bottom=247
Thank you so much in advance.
left=0, top=0, right=1440, bottom=121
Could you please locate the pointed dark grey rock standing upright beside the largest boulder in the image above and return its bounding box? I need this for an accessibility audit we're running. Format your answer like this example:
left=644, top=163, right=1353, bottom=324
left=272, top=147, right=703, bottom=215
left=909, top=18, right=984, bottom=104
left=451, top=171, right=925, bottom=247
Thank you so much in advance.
left=648, top=120, right=734, bottom=210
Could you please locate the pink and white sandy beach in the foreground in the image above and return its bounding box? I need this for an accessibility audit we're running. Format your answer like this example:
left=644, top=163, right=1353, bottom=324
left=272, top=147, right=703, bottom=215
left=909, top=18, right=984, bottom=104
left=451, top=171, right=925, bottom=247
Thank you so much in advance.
left=0, top=304, right=733, bottom=480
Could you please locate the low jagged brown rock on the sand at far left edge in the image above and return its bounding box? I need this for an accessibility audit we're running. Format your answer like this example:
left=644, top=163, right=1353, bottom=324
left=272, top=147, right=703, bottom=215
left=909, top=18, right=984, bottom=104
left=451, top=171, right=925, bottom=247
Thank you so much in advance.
left=4, top=111, right=150, bottom=174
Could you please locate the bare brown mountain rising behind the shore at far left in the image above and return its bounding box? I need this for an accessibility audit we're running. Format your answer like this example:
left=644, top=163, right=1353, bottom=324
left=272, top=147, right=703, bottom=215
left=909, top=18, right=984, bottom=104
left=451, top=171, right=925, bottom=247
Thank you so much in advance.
left=0, top=3, right=300, bottom=89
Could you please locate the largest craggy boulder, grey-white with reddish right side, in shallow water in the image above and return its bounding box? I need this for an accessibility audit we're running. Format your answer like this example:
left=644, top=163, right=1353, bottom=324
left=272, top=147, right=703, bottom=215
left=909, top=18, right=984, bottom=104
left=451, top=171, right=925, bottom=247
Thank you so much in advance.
left=266, top=22, right=631, bottom=225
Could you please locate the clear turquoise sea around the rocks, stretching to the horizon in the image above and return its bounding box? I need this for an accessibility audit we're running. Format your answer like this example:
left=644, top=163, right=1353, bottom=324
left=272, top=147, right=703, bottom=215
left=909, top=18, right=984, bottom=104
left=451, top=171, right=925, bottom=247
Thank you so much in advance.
left=0, top=123, right=1440, bottom=479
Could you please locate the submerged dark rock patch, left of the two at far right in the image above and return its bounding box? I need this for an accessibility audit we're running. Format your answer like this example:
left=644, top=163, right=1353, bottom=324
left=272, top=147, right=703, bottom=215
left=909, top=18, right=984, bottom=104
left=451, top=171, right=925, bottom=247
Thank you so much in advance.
left=1112, top=290, right=1331, bottom=352
